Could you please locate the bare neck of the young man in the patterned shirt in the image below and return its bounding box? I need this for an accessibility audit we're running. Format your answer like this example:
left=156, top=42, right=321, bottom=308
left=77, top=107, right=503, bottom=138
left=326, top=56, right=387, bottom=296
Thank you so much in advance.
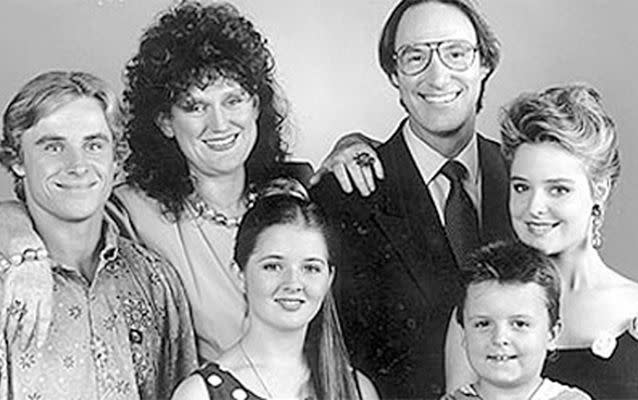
left=30, top=206, right=104, bottom=281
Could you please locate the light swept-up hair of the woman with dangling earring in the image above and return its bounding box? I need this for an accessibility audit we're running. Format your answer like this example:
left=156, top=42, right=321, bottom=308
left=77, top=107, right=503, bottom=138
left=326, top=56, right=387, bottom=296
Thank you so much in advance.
left=501, top=84, right=620, bottom=200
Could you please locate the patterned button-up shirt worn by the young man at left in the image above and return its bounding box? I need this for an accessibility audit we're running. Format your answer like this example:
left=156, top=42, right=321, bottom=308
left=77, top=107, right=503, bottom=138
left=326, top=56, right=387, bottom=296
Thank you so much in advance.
left=0, top=223, right=196, bottom=400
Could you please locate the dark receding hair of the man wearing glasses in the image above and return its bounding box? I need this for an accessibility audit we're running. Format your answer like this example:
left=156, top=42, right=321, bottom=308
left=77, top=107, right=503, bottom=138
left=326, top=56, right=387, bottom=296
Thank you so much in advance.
left=379, top=0, right=501, bottom=112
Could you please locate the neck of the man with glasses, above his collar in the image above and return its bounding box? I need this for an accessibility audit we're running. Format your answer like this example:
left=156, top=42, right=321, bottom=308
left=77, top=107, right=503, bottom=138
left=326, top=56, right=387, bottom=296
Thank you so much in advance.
left=408, top=117, right=476, bottom=159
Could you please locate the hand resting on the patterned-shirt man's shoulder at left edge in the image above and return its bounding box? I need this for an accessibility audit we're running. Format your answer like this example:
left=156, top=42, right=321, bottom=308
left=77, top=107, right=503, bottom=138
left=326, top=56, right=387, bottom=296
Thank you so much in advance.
left=0, top=248, right=53, bottom=349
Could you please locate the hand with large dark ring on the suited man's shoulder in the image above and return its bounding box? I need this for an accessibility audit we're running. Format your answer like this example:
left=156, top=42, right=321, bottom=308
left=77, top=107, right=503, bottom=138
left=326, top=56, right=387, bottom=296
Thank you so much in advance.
left=310, top=132, right=384, bottom=197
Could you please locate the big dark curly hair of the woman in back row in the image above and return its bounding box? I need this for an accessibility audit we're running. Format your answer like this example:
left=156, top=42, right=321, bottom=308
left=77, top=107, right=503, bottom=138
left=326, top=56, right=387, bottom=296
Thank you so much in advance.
left=124, top=0, right=288, bottom=219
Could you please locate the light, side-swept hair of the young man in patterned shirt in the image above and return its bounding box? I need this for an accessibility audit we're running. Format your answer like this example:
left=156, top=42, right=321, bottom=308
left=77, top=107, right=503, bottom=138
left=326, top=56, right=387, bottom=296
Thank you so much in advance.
left=0, top=71, right=128, bottom=200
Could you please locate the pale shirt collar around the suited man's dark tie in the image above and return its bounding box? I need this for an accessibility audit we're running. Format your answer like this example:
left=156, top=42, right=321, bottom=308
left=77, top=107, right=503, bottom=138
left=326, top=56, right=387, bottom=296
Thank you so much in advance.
left=403, top=121, right=479, bottom=184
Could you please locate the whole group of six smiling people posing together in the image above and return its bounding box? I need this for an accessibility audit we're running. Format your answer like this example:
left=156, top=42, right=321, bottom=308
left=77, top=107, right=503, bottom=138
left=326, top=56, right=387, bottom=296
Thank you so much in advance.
left=0, top=0, right=638, bottom=400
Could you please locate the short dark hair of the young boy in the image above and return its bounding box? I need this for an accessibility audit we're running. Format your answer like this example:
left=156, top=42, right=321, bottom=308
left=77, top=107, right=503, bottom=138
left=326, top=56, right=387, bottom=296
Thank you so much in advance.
left=456, top=241, right=561, bottom=327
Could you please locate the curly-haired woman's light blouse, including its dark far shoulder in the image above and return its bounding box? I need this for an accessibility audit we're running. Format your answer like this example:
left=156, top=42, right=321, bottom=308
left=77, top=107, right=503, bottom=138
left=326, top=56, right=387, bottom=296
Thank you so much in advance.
left=108, top=163, right=312, bottom=361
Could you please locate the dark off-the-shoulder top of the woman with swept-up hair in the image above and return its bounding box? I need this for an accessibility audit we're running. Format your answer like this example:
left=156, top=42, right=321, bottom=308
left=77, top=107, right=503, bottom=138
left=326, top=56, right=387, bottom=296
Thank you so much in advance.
left=544, top=331, right=638, bottom=400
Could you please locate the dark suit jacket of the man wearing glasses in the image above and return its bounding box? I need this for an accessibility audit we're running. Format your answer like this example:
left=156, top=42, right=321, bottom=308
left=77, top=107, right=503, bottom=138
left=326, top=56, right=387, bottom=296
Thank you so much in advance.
left=313, top=124, right=513, bottom=399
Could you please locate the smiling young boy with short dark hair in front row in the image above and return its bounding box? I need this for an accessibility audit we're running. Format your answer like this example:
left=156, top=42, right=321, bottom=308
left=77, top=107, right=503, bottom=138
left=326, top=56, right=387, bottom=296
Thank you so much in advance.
left=444, top=242, right=590, bottom=400
